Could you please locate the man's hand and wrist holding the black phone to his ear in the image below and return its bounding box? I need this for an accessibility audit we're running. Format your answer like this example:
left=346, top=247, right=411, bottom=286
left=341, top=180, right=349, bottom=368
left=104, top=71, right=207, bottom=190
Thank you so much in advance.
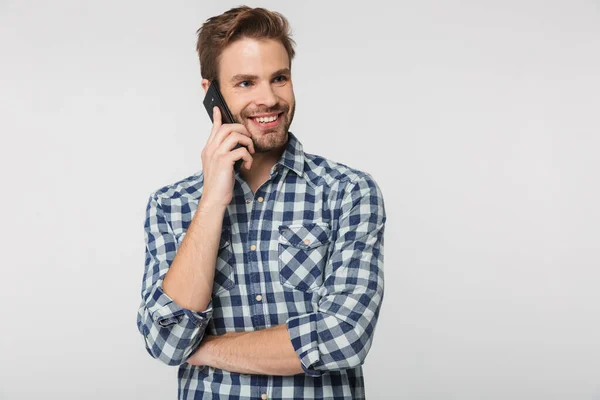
left=202, top=107, right=255, bottom=207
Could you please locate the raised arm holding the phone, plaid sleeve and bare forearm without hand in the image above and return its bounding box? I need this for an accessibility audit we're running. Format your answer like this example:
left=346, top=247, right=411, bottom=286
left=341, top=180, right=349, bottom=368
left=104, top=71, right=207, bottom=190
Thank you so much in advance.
left=137, top=196, right=222, bottom=365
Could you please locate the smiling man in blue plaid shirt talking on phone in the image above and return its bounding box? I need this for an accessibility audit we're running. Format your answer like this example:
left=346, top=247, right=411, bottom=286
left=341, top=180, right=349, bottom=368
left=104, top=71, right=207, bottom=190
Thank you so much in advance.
left=138, top=6, right=386, bottom=399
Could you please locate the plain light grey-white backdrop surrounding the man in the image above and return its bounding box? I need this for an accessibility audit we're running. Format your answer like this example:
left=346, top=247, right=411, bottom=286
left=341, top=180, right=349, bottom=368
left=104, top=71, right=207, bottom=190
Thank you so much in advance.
left=0, top=0, right=600, bottom=400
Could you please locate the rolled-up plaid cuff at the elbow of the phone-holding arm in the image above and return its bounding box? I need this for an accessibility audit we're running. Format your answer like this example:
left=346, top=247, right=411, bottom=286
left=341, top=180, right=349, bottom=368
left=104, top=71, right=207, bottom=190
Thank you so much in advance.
left=147, top=282, right=213, bottom=327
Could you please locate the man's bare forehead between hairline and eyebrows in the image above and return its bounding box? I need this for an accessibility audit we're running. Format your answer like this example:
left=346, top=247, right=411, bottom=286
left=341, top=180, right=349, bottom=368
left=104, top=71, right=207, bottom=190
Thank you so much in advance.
left=219, top=38, right=290, bottom=80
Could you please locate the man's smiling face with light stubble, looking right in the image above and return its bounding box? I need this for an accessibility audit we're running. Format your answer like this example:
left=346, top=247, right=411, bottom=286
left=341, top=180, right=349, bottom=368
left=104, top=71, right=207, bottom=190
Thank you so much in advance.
left=207, top=38, right=296, bottom=153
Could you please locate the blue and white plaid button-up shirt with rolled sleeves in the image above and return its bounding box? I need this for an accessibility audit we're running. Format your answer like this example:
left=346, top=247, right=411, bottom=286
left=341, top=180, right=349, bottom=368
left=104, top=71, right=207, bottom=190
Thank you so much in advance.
left=137, top=132, right=386, bottom=400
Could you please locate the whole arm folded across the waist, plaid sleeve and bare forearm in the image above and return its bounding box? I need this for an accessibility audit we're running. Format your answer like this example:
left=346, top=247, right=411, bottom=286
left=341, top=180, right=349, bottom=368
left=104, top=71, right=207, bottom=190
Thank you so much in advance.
left=188, top=174, right=386, bottom=376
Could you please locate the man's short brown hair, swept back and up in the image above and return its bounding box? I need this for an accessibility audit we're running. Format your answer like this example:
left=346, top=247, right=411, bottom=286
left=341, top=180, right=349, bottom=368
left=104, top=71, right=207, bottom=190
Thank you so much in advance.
left=196, top=6, right=296, bottom=81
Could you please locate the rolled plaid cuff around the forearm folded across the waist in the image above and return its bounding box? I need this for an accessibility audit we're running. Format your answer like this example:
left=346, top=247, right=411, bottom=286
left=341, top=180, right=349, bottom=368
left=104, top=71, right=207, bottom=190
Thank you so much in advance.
left=286, top=314, right=323, bottom=376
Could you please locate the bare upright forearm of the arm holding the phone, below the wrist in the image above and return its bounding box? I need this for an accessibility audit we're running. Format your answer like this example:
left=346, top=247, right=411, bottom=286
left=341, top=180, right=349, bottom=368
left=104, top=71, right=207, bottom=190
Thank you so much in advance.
left=163, top=200, right=225, bottom=311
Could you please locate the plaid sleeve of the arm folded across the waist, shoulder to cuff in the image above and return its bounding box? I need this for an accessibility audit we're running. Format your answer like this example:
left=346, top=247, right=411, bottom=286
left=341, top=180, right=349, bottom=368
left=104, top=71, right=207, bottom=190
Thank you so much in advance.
left=286, top=174, right=386, bottom=376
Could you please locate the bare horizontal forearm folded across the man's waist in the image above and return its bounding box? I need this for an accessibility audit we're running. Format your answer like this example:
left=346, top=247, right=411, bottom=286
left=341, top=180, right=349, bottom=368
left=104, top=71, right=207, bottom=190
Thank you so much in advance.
left=188, top=324, right=303, bottom=375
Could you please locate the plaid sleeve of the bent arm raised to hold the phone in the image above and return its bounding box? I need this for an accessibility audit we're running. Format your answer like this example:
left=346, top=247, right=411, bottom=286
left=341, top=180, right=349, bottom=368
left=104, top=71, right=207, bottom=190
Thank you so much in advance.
left=137, top=196, right=212, bottom=365
